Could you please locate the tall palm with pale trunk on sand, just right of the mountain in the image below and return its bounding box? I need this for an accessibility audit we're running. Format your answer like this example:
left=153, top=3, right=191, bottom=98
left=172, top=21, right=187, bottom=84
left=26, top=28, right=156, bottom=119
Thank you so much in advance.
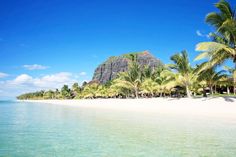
left=169, top=50, right=195, bottom=97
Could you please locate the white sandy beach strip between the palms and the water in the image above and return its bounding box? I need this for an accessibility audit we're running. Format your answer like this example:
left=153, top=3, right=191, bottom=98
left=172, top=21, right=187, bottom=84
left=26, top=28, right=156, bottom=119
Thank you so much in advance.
left=21, top=97, right=236, bottom=119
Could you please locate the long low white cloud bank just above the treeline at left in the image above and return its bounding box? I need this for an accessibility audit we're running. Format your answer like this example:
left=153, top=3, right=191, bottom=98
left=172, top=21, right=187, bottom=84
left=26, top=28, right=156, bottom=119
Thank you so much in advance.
left=0, top=72, right=80, bottom=99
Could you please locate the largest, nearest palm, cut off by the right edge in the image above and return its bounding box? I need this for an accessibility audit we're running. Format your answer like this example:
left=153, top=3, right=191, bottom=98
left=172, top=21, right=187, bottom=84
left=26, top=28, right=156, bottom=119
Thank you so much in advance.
left=195, top=0, right=236, bottom=93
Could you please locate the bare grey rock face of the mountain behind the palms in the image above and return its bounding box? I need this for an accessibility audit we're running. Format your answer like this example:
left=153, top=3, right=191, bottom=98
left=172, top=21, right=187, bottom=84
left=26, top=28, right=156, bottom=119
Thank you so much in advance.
left=93, top=51, right=162, bottom=84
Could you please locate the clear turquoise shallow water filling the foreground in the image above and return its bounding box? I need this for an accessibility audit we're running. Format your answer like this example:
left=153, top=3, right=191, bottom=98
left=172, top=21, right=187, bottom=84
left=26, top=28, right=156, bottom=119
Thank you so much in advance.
left=0, top=102, right=236, bottom=157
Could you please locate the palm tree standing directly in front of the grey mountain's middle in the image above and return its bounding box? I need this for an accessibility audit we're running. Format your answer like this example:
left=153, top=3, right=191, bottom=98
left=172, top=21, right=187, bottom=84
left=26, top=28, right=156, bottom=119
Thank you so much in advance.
left=114, top=61, right=142, bottom=98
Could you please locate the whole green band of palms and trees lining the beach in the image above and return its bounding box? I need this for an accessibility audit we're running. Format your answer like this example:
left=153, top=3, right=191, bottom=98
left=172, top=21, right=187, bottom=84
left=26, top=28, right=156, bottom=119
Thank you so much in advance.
left=17, top=0, right=236, bottom=99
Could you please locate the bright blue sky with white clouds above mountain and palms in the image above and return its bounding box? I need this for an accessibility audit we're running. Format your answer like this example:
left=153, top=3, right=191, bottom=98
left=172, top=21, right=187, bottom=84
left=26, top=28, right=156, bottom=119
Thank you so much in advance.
left=0, top=0, right=236, bottom=99
